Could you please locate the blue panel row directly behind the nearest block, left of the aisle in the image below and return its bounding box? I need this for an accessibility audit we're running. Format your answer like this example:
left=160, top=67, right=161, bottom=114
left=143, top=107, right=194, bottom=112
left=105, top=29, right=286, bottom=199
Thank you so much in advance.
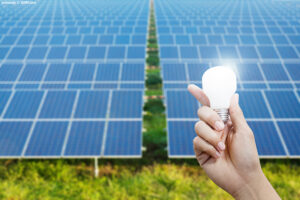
left=0, top=63, right=145, bottom=90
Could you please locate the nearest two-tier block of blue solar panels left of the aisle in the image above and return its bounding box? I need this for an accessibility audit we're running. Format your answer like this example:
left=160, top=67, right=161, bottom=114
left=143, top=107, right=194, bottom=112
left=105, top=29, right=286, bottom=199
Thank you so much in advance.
left=0, top=90, right=143, bottom=158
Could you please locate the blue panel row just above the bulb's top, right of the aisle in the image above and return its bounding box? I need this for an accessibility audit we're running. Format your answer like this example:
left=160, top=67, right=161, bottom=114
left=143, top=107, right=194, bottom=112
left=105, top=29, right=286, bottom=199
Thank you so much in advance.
left=160, top=45, right=300, bottom=61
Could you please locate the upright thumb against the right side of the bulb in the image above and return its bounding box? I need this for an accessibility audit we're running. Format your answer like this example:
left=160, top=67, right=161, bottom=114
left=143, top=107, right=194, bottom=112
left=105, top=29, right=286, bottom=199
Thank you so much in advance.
left=229, top=94, right=247, bottom=130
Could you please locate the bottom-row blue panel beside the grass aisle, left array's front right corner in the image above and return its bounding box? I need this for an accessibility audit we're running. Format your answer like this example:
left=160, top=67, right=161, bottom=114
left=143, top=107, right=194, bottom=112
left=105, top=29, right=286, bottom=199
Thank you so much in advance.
left=104, top=121, right=142, bottom=157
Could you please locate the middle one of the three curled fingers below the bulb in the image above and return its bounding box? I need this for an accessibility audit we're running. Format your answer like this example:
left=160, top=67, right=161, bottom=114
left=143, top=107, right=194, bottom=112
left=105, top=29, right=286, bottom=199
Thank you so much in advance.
left=195, top=121, right=225, bottom=151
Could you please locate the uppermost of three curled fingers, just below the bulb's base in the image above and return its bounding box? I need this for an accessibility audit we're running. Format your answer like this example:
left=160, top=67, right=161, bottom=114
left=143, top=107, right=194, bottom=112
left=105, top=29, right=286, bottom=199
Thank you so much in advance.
left=198, top=106, right=225, bottom=131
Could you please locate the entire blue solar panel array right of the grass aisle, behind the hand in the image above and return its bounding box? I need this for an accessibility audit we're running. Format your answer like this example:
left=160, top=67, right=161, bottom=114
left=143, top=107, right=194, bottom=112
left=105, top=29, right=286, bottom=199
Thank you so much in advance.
left=155, top=0, right=300, bottom=157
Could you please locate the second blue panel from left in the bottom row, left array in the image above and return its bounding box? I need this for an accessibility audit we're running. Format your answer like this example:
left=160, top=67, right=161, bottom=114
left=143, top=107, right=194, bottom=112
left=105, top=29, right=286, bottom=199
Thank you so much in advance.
left=25, top=122, right=68, bottom=157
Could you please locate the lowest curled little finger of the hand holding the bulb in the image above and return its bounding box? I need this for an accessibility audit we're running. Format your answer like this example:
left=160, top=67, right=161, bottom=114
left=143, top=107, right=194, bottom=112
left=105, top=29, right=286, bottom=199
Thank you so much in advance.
left=193, top=137, right=221, bottom=159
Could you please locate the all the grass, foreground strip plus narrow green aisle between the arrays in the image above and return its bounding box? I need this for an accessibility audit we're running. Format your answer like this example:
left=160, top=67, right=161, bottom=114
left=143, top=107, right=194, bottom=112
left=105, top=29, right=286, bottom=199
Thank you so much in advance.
left=0, top=0, right=300, bottom=200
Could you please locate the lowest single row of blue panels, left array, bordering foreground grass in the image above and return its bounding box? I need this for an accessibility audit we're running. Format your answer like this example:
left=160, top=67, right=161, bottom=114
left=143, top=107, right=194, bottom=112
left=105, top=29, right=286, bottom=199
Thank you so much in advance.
left=0, top=120, right=142, bottom=158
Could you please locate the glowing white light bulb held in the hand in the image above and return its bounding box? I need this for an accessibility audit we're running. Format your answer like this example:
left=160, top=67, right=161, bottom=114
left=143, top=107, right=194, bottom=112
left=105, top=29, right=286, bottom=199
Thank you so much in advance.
left=202, top=66, right=236, bottom=122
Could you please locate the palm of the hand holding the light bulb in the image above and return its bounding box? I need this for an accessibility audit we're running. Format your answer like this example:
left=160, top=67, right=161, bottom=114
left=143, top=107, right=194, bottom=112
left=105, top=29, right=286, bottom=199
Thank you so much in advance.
left=201, top=122, right=259, bottom=195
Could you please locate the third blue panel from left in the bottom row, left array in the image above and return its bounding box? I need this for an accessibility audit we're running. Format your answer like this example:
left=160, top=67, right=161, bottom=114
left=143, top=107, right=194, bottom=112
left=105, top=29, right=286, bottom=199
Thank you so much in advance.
left=64, top=121, right=104, bottom=156
